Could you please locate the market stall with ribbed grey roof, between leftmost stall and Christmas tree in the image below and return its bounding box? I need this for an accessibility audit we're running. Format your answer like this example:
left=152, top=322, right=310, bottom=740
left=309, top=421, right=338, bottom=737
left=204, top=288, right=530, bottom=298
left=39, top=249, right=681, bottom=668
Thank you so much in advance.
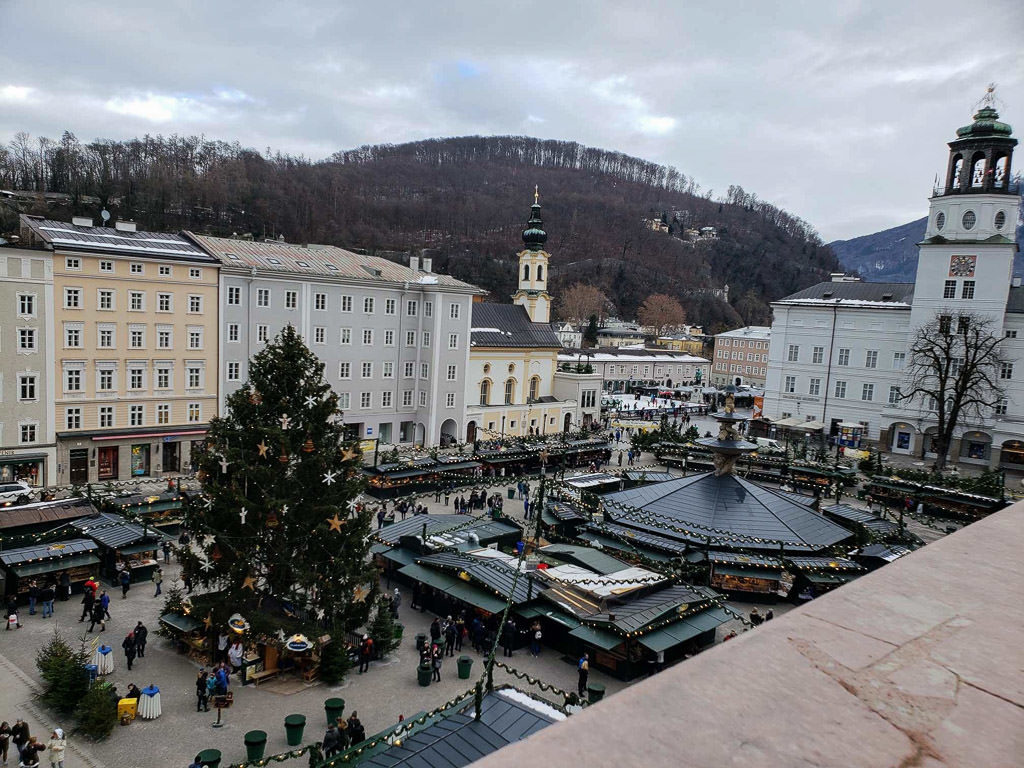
left=72, top=512, right=164, bottom=586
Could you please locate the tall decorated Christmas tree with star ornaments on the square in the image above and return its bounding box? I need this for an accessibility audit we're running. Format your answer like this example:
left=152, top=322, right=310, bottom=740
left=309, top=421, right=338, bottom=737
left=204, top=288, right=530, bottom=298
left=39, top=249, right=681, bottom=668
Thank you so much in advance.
left=185, top=326, right=377, bottom=639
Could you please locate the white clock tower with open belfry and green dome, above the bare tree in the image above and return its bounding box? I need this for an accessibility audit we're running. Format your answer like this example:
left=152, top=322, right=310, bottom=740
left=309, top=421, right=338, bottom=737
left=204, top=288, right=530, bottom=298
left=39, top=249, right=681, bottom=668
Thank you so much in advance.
left=910, top=88, right=1020, bottom=328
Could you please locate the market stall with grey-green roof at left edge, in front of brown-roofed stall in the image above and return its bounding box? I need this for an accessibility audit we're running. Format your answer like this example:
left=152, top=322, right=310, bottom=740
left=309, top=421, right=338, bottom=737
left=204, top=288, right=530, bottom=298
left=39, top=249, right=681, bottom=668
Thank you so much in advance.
left=0, top=539, right=99, bottom=599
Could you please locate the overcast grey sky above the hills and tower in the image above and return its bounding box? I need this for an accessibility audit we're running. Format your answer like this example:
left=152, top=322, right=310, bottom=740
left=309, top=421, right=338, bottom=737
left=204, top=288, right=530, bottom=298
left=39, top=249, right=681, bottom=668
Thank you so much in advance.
left=0, top=0, right=1024, bottom=240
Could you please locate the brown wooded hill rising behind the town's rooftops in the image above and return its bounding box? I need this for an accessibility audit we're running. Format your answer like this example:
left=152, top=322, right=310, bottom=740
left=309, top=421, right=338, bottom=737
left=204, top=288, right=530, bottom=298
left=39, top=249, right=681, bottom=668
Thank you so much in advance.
left=0, top=133, right=838, bottom=330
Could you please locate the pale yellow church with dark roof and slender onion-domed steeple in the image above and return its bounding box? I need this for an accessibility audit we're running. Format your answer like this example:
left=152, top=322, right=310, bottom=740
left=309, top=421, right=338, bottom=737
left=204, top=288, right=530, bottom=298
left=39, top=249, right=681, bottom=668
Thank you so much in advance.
left=466, top=198, right=600, bottom=441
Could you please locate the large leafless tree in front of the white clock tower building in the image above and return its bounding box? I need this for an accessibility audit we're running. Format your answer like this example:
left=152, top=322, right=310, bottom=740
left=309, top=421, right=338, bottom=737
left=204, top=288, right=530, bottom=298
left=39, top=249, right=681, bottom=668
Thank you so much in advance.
left=900, top=312, right=1009, bottom=471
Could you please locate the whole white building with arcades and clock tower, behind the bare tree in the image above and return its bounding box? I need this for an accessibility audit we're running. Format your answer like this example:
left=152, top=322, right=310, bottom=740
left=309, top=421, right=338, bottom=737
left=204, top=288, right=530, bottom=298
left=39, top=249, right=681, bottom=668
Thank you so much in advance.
left=764, top=106, right=1024, bottom=472
